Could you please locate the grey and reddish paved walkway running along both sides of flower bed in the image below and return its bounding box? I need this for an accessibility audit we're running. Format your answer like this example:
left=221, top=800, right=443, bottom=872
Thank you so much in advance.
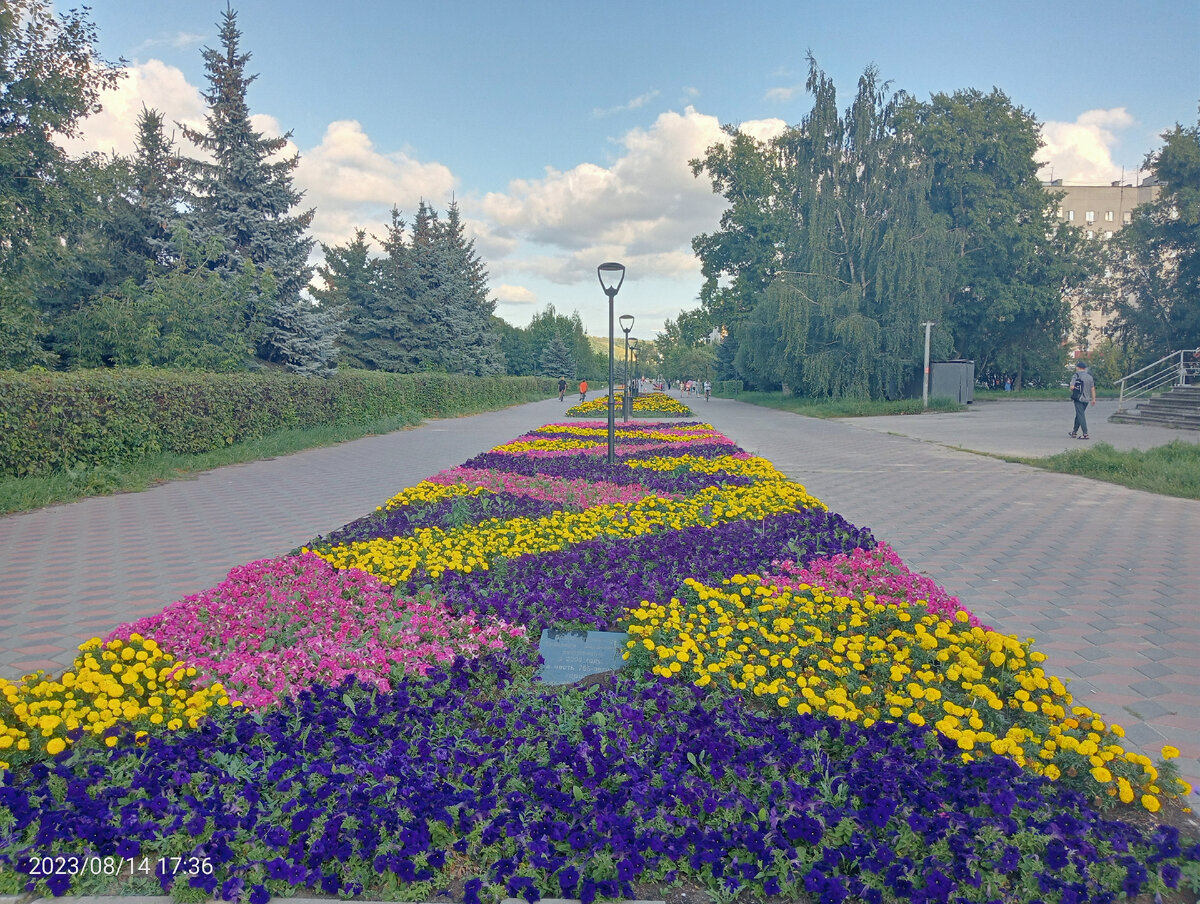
left=0, top=400, right=1200, bottom=801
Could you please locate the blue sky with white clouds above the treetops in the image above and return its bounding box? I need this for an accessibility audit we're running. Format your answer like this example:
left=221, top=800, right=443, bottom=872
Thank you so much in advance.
left=72, top=0, right=1200, bottom=337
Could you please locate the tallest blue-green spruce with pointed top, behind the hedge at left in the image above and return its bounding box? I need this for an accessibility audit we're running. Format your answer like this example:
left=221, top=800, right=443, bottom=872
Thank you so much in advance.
left=184, top=8, right=336, bottom=372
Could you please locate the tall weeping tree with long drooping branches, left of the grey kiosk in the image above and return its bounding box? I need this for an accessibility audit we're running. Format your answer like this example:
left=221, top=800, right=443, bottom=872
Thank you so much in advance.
left=692, top=55, right=952, bottom=399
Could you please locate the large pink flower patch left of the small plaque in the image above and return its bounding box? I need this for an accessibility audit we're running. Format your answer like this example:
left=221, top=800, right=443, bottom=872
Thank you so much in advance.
left=108, top=553, right=526, bottom=707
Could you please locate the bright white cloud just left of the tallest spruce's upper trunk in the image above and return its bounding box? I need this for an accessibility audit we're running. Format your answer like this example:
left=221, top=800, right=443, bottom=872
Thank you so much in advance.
left=62, top=60, right=206, bottom=155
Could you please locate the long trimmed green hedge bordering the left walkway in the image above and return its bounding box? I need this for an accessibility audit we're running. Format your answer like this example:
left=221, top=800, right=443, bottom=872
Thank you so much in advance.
left=0, top=369, right=557, bottom=477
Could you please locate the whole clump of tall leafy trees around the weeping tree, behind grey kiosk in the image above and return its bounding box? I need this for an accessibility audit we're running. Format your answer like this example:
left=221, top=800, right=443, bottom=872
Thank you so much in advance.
left=692, top=70, right=1094, bottom=399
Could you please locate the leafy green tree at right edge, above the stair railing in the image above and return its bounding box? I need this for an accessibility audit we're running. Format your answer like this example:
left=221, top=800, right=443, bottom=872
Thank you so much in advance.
left=1094, top=113, right=1200, bottom=362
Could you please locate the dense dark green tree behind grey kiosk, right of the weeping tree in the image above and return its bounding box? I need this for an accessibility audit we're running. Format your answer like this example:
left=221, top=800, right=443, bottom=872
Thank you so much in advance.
left=898, top=89, right=1090, bottom=388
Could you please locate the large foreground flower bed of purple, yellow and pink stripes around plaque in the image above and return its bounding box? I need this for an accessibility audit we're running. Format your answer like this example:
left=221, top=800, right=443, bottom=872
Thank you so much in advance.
left=0, top=424, right=1200, bottom=904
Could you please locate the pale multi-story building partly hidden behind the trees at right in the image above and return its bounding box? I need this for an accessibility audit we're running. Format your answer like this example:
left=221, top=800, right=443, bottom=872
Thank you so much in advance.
left=1045, top=176, right=1162, bottom=358
